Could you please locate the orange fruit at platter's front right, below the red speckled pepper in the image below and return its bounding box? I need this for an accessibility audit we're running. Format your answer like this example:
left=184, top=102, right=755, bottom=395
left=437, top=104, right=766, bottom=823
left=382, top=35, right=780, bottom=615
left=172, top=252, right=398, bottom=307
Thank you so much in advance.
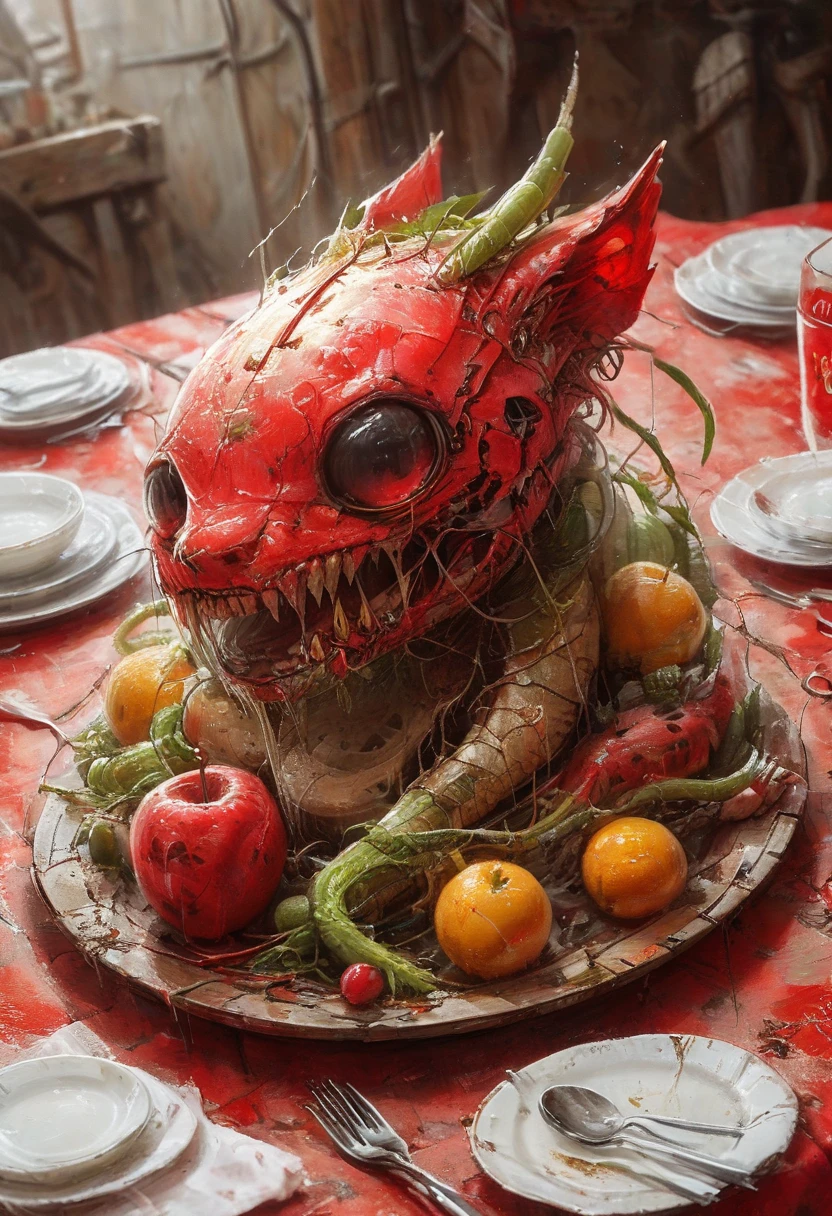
left=581, top=815, right=687, bottom=921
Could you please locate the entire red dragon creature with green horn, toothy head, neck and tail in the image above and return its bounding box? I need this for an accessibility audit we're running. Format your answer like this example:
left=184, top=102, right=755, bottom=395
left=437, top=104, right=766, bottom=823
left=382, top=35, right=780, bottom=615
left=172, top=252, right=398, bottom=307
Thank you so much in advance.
left=130, top=71, right=749, bottom=991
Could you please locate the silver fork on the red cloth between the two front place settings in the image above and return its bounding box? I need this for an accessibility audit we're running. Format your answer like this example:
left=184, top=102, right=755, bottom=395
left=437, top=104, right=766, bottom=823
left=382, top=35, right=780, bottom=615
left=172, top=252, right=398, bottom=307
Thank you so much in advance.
left=307, top=1081, right=482, bottom=1216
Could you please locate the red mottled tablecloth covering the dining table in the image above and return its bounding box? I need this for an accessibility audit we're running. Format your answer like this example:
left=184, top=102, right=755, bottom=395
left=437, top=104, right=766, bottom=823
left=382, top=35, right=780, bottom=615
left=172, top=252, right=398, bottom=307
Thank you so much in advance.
left=0, top=204, right=832, bottom=1216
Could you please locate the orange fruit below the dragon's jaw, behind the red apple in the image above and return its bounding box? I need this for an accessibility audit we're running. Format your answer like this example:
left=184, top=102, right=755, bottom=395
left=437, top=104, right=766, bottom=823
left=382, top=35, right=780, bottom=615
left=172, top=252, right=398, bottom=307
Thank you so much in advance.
left=105, top=646, right=193, bottom=745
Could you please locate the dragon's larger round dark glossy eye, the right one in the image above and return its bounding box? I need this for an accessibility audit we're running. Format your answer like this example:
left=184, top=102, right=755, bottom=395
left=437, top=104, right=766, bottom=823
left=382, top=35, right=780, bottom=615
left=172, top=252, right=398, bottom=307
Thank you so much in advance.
left=324, top=400, right=442, bottom=511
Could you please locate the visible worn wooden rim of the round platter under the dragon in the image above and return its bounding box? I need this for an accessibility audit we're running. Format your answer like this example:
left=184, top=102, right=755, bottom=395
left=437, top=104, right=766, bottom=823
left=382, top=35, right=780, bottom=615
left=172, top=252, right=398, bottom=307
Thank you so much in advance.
left=33, top=693, right=805, bottom=1042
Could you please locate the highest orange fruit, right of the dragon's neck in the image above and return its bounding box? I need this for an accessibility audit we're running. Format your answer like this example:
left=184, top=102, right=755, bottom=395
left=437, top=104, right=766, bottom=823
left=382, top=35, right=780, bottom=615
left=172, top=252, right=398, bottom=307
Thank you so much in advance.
left=602, top=562, right=708, bottom=676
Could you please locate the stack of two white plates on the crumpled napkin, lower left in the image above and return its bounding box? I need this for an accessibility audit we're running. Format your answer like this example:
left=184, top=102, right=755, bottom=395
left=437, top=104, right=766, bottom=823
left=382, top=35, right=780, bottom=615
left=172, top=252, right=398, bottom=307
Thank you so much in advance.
left=0, top=1055, right=197, bottom=1211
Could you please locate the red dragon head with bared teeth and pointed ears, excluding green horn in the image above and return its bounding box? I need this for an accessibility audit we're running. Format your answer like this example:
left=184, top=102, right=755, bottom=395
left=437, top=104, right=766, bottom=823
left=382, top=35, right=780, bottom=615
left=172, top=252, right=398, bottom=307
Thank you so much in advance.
left=145, top=128, right=660, bottom=700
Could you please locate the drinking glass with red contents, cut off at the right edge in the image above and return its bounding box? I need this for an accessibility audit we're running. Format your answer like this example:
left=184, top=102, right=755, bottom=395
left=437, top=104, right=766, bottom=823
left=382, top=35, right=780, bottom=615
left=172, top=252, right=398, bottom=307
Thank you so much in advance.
left=797, top=237, right=832, bottom=451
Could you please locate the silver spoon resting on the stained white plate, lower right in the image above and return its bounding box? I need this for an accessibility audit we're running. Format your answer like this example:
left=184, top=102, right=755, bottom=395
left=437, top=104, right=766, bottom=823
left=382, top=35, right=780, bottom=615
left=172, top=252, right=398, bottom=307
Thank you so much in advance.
left=540, top=1085, right=754, bottom=1190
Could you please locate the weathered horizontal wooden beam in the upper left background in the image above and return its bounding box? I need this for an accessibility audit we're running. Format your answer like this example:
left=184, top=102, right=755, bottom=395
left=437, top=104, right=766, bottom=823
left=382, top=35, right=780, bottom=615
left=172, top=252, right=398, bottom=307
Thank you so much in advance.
left=0, top=114, right=165, bottom=212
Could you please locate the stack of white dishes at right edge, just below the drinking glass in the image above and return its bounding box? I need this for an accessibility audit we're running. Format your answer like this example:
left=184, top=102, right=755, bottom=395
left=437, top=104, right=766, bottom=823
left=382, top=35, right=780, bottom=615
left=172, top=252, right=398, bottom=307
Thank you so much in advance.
left=710, top=451, right=832, bottom=567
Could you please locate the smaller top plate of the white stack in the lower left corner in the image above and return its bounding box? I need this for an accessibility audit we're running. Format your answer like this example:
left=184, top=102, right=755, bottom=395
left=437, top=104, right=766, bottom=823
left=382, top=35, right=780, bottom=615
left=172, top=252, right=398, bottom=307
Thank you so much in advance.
left=0, top=1055, right=153, bottom=1187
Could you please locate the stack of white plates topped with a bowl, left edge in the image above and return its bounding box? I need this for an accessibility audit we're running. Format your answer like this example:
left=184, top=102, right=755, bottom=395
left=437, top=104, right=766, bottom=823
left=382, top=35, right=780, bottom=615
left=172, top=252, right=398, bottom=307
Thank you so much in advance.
left=0, top=473, right=146, bottom=632
